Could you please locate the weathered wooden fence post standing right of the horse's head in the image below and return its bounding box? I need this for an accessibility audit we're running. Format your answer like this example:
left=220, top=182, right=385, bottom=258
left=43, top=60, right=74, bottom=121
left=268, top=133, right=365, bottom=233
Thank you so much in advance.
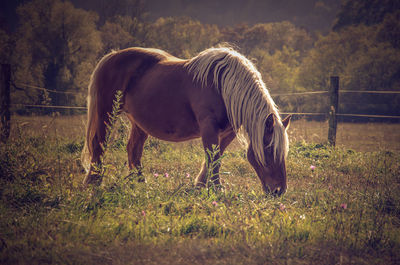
left=328, top=76, right=339, bottom=146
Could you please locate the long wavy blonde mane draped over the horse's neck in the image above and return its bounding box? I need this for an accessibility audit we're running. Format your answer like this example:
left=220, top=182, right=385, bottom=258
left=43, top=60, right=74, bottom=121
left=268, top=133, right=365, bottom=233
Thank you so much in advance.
left=185, top=47, right=289, bottom=165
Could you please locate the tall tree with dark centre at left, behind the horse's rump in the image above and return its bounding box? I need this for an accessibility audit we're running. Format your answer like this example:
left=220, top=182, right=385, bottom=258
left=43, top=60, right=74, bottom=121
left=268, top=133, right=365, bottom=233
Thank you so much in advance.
left=13, top=0, right=102, bottom=109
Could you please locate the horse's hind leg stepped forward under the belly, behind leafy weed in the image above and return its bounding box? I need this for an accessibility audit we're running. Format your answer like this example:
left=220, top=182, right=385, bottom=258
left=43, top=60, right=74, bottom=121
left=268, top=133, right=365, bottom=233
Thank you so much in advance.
left=127, top=120, right=148, bottom=181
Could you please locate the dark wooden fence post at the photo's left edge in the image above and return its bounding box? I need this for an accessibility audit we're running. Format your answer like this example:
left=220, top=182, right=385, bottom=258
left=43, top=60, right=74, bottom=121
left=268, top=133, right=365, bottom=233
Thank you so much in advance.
left=0, top=64, right=11, bottom=143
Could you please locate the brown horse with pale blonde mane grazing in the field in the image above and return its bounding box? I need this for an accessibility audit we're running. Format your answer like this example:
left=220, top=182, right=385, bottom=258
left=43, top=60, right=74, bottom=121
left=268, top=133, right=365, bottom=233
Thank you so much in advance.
left=82, top=48, right=290, bottom=195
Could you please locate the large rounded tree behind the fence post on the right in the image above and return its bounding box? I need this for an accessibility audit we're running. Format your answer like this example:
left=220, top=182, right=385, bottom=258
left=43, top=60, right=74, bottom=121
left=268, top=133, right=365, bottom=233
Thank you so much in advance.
left=297, top=25, right=400, bottom=114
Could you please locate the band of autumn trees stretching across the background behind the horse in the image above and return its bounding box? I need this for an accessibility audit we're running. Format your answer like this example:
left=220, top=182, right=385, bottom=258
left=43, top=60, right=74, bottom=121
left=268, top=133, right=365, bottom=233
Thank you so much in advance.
left=0, top=0, right=400, bottom=115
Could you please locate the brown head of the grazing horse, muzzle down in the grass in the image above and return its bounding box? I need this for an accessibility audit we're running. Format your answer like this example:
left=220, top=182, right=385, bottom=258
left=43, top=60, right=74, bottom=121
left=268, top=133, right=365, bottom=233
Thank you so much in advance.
left=247, top=114, right=291, bottom=196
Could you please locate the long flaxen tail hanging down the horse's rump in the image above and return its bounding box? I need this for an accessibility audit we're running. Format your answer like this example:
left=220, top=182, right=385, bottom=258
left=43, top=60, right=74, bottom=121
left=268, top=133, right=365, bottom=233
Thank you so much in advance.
left=81, top=52, right=116, bottom=173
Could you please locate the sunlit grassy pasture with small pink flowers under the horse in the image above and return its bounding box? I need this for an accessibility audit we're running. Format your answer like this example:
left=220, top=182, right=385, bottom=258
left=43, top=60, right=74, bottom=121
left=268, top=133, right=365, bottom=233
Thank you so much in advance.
left=0, top=116, right=400, bottom=264
